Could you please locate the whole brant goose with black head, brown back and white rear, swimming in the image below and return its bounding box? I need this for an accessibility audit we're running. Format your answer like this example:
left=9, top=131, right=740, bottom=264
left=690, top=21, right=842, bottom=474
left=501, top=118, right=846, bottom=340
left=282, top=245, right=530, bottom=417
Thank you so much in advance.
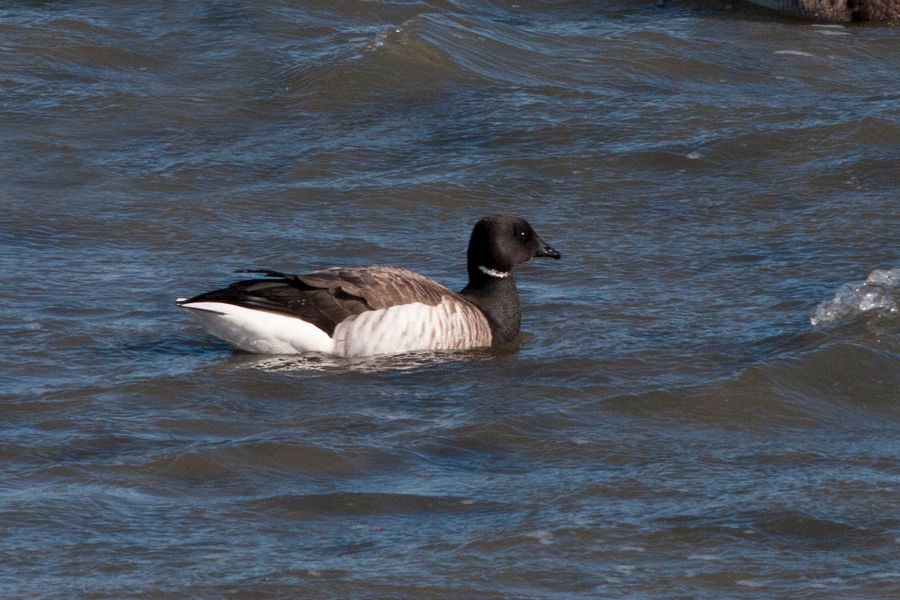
left=176, top=216, right=560, bottom=357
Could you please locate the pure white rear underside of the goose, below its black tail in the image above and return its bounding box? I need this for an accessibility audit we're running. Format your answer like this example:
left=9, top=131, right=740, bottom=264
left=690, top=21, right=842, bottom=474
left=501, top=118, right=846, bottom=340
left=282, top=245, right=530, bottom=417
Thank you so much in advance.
left=179, top=302, right=335, bottom=354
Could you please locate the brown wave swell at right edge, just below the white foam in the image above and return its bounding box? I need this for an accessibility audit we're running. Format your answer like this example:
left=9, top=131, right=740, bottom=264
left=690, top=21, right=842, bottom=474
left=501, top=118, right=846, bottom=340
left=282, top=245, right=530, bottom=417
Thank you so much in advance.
left=601, top=336, right=900, bottom=430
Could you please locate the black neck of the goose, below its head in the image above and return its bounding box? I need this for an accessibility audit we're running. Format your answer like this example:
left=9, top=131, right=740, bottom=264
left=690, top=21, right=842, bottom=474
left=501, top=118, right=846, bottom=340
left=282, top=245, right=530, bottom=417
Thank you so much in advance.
left=460, top=266, right=522, bottom=346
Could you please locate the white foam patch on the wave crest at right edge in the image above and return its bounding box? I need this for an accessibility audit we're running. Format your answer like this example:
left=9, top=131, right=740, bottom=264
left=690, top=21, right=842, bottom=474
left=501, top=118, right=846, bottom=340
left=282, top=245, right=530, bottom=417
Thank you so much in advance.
left=809, top=268, right=900, bottom=326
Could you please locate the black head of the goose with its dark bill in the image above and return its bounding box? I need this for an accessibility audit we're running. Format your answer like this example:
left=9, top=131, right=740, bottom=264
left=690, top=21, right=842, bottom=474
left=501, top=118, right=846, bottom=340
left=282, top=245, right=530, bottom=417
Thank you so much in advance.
left=468, top=215, right=560, bottom=276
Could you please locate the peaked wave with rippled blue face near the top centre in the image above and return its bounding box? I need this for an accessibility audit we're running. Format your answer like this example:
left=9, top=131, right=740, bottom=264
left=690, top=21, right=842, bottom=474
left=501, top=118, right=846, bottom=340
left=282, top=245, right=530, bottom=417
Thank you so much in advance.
left=282, top=12, right=596, bottom=110
